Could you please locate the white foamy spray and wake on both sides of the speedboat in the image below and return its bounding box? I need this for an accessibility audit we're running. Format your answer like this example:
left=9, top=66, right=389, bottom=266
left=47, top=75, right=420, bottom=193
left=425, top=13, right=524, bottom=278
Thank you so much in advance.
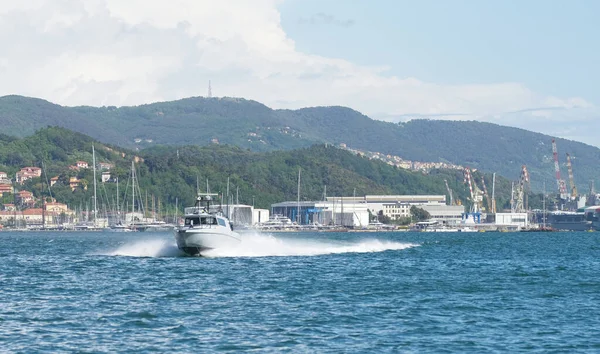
left=103, top=233, right=418, bottom=258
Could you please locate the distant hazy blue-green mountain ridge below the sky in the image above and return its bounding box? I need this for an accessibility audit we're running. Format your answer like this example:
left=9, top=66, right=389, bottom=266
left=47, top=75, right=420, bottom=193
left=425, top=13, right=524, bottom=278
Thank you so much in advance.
left=0, top=96, right=600, bottom=192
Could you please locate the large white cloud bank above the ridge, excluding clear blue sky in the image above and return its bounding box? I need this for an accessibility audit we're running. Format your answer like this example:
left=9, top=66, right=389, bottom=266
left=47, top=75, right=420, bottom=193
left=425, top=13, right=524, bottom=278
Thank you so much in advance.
left=0, top=0, right=600, bottom=144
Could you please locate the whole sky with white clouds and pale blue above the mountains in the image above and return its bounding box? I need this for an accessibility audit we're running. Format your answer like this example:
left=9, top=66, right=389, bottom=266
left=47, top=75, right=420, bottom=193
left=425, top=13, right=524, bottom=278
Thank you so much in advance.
left=0, top=0, right=600, bottom=146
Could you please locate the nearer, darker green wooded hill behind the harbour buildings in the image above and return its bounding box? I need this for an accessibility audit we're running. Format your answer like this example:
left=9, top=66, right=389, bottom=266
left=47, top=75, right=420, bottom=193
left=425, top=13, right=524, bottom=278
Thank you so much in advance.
left=0, top=127, right=539, bottom=212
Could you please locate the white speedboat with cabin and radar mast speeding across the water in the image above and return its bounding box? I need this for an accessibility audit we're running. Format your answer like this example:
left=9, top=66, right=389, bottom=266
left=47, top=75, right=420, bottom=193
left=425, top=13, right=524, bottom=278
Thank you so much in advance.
left=175, top=193, right=241, bottom=255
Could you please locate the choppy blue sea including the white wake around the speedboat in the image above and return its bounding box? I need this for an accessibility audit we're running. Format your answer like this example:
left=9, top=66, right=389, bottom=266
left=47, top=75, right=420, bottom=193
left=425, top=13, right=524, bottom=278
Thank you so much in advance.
left=0, top=231, right=600, bottom=353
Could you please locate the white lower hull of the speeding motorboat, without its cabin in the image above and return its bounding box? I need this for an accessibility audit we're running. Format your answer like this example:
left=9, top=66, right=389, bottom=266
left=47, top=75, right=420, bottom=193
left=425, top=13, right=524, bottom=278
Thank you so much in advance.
left=175, top=227, right=241, bottom=255
